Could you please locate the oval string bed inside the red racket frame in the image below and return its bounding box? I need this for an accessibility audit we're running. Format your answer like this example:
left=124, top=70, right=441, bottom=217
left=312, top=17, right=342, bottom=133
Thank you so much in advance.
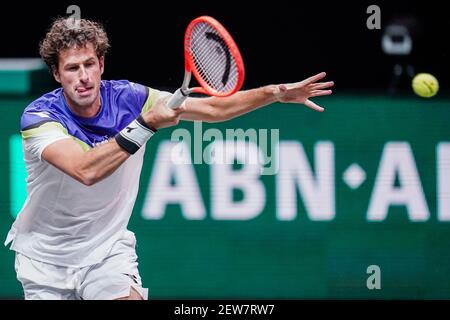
left=187, top=23, right=238, bottom=92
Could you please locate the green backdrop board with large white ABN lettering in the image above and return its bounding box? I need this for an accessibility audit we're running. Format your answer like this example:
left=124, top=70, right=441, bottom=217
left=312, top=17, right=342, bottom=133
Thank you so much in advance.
left=0, top=93, right=450, bottom=299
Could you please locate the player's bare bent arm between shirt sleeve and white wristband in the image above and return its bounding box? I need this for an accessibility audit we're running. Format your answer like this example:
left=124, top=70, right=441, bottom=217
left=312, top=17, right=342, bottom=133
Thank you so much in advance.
left=42, top=138, right=130, bottom=186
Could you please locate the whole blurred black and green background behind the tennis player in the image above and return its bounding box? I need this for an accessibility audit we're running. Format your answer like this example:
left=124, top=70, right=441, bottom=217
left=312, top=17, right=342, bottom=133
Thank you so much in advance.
left=0, top=1, right=450, bottom=299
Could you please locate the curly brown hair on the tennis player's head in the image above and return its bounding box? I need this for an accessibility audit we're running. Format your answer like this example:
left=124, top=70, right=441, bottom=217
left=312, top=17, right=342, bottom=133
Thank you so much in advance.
left=39, top=18, right=110, bottom=71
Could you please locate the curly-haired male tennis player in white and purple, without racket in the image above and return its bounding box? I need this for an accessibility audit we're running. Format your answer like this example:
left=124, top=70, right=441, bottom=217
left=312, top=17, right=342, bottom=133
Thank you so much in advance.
left=5, top=18, right=333, bottom=300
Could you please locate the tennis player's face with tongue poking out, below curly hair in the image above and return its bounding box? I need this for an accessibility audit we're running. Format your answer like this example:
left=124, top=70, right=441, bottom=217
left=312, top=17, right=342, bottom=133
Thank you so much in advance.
left=53, top=43, right=104, bottom=113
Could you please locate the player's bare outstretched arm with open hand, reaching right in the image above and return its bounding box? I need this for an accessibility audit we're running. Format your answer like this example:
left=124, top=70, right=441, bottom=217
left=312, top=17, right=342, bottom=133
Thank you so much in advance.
left=181, top=72, right=334, bottom=122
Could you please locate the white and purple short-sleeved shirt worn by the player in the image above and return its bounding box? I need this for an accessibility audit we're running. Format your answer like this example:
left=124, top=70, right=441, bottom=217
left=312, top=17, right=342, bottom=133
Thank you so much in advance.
left=5, top=81, right=165, bottom=267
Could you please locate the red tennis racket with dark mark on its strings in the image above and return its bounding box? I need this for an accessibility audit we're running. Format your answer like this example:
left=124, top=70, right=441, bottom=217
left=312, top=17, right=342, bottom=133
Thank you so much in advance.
left=167, top=16, right=245, bottom=109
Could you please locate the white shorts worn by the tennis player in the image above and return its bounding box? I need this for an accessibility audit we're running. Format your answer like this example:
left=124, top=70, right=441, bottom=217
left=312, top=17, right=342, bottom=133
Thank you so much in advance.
left=15, top=230, right=148, bottom=300
